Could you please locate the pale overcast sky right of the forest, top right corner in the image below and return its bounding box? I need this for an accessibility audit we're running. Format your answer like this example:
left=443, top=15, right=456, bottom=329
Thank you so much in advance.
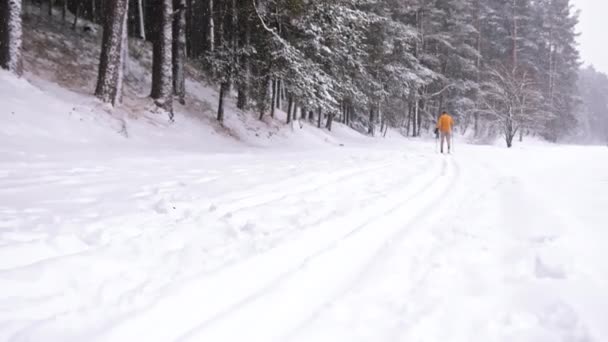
left=572, top=0, right=608, bottom=73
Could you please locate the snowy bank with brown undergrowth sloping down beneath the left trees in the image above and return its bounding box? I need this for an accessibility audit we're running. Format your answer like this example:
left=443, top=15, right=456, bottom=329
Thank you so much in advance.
left=8, top=11, right=376, bottom=152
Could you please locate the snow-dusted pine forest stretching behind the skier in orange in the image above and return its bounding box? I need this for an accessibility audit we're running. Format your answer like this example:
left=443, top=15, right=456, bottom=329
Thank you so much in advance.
left=0, top=0, right=605, bottom=147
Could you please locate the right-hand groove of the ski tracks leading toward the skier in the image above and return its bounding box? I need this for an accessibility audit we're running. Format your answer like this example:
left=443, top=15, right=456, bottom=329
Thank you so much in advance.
left=173, top=161, right=458, bottom=341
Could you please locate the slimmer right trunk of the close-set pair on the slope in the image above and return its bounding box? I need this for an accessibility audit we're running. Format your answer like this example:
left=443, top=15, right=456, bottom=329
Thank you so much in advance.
left=172, top=0, right=186, bottom=105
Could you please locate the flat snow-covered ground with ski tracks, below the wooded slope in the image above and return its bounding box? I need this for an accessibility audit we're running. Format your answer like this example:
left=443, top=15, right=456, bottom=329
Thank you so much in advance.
left=0, top=144, right=608, bottom=342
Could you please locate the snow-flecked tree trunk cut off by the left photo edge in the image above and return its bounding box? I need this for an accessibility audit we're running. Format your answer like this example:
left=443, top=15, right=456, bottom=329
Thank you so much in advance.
left=0, top=0, right=23, bottom=75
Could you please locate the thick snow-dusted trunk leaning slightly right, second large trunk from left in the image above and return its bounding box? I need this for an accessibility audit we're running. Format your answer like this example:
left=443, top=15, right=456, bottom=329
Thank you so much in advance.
left=95, top=0, right=129, bottom=106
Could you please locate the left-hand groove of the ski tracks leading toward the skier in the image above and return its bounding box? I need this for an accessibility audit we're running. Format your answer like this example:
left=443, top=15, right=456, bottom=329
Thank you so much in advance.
left=85, top=154, right=452, bottom=341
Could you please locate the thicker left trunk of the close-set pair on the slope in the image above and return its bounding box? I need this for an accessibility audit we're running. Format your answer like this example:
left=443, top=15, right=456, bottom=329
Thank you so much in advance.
left=150, top=0, right=173, bottom=119
